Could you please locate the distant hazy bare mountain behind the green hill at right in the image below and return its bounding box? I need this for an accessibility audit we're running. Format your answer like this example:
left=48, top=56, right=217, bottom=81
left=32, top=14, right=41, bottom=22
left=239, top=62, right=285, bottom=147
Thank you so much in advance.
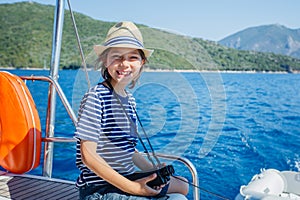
left=219, top=24, right=300, bottom=58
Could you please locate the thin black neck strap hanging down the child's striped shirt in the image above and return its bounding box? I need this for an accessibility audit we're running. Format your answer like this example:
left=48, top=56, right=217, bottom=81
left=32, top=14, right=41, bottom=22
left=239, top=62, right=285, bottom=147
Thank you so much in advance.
left=105, top=80, right=161, bottom=169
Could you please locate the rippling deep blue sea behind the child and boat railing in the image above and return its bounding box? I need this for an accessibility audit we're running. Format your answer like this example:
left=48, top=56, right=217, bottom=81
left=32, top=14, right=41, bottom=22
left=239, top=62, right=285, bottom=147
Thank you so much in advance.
left=2, top=70, right=300, bottom=199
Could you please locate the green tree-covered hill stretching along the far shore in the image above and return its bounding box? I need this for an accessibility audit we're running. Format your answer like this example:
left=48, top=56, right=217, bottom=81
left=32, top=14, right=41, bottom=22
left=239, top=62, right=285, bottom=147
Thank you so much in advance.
left=0, top=2, right=300, bottom=71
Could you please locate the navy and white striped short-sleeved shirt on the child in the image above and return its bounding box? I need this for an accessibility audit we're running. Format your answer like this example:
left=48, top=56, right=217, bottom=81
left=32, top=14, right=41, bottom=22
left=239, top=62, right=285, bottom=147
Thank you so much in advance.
left=75, top=83, right=138, bottom=187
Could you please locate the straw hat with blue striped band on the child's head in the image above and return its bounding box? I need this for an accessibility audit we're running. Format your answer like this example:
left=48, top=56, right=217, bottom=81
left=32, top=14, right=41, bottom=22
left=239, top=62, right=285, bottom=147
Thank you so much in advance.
left=94, top=21, right=153, bottom=58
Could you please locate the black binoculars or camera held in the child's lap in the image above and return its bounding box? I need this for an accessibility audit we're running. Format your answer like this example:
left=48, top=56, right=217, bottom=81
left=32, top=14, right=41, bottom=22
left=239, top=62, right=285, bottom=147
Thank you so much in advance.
left=130, top=165, right=175, bottom=187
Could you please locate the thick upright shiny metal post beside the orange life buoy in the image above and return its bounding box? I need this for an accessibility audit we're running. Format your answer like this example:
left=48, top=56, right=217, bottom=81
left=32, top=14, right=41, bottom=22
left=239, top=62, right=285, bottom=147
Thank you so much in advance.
left=43, top=0, right=65, bottom=177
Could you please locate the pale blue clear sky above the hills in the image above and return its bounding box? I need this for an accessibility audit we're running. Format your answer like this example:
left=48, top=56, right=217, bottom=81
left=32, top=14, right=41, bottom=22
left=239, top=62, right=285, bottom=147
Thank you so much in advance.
left=0, top=0, right=300, bottom=41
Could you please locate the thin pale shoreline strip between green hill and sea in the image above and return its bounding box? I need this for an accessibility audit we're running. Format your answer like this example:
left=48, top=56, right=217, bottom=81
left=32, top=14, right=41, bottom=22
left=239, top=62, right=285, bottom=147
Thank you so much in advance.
left=0, top=67, right=300, bottom=74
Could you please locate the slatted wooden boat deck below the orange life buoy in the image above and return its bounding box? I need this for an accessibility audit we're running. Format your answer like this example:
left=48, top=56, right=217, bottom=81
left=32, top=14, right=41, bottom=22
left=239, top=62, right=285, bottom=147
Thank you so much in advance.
left=0, top=173, right=79, bottom=200
